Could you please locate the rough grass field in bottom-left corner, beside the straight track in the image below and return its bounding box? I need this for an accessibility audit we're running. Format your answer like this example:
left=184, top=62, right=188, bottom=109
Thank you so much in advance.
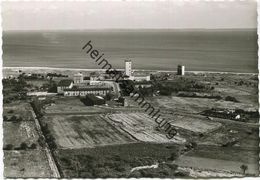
left=4, top=150, right=52, bottom=178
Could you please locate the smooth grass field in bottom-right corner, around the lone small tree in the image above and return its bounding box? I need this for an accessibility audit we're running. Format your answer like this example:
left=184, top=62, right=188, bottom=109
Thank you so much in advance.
left=175, top=146, right=259, bottom=175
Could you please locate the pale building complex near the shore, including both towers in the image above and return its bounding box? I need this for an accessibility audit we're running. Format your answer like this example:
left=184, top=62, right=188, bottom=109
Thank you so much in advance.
left=57, top=60, right=185, bottom=97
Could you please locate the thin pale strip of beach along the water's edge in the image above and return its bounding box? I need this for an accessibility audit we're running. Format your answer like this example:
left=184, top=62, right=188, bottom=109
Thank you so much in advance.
left=3, top=67, right=258, bottom=75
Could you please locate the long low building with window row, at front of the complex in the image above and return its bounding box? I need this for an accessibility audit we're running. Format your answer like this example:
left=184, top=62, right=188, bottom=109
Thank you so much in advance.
left=64, top=86, right=112, bottom=96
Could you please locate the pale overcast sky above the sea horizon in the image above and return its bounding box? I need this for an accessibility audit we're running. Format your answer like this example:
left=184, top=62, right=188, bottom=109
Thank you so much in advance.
left=2, top=0, right=257, bottom=30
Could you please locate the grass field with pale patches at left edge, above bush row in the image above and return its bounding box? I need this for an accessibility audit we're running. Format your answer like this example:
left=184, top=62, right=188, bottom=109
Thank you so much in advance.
left=3, top=121, right=39, bottom=148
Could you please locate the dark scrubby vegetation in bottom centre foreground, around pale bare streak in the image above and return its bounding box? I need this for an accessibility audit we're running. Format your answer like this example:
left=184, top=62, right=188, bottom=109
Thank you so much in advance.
left=57, top=143, right=181, bottom=178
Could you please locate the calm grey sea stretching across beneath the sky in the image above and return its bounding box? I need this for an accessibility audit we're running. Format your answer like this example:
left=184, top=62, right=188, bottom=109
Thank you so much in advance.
left=3, top=29, right=258, bottom=73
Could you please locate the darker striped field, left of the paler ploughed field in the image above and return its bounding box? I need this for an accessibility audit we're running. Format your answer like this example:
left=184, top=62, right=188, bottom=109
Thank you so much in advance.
left=42, top=115, right=134, bottom=149
